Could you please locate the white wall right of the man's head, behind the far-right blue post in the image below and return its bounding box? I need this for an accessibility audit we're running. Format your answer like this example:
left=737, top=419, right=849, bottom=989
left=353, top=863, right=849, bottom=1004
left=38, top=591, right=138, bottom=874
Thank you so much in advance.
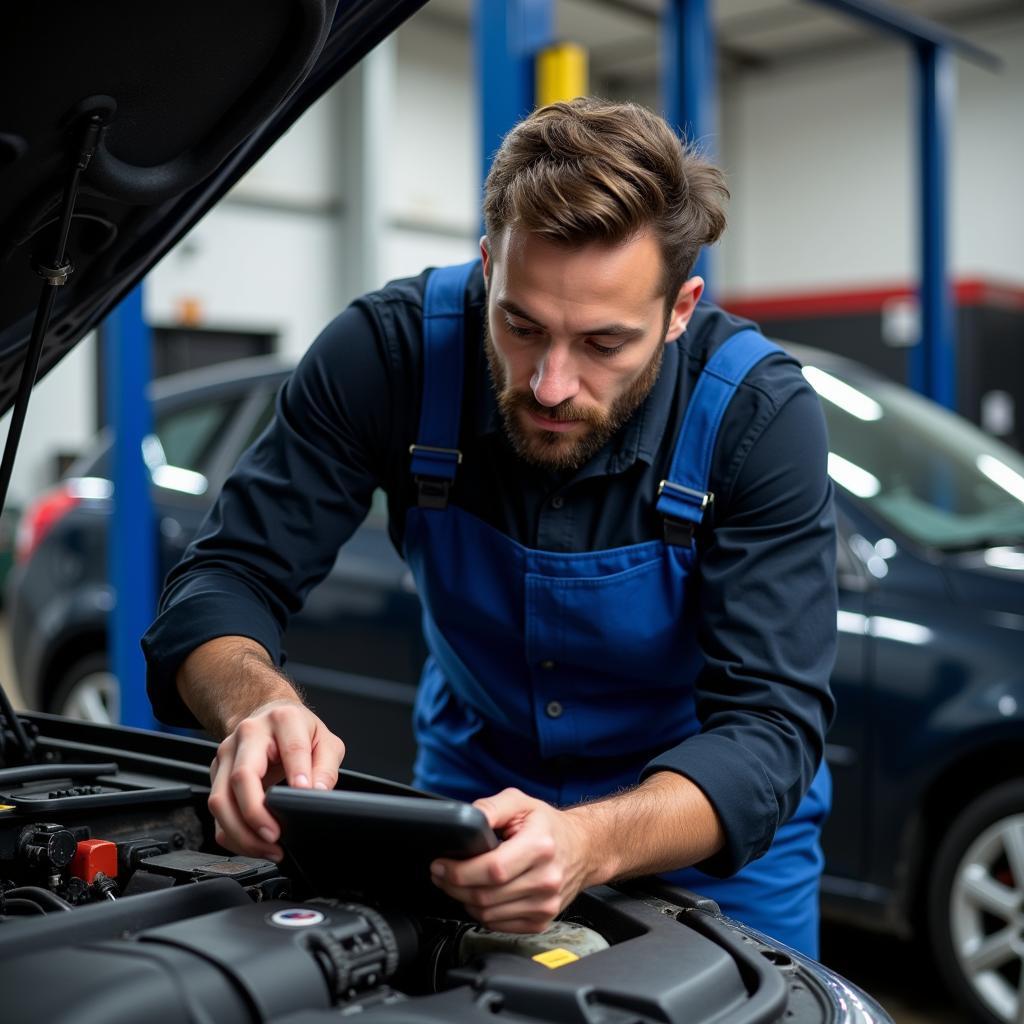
left=720, top=17, right=1024, bottom=295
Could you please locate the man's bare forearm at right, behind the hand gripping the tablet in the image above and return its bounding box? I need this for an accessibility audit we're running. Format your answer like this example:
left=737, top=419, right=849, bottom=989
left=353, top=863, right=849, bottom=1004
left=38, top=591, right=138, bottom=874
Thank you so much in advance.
left=566, top=771, right=725, bottom=886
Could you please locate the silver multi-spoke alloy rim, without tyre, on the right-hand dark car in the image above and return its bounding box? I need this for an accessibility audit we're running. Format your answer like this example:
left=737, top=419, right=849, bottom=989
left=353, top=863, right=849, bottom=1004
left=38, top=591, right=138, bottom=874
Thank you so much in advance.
left=949, top=814, right=1024, bottom=1024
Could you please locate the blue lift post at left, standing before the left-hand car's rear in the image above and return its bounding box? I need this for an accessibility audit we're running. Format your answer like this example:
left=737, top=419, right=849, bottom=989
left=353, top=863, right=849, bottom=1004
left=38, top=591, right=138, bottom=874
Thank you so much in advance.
left=102, top=285, right=159, bottom=728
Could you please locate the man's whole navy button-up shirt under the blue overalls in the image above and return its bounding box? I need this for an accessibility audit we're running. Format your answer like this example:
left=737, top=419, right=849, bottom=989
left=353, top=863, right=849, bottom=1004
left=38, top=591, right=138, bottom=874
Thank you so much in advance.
left=142, top=271, right=836, bottom=873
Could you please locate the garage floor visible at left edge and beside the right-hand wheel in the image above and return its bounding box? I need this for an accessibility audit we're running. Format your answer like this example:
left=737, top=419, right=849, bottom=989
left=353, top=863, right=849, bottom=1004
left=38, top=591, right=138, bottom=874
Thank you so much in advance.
left=0, top=615, right=967, bottom=1024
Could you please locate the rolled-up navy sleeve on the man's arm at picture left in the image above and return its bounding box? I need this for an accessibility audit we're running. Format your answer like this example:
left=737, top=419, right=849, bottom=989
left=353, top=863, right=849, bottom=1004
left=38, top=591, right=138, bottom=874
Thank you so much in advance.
left=142, top=306, right=392, bottom=726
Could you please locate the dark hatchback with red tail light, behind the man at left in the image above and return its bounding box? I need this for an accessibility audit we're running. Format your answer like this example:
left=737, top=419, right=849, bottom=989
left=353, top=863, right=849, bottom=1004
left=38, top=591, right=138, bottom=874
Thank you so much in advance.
left=8, top=357, right=426, bottom=779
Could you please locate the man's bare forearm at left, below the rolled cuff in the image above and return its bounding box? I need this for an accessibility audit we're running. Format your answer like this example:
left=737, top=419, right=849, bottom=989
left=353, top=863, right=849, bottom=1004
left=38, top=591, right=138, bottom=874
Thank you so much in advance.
left=175, top=637, right=302, bottom=739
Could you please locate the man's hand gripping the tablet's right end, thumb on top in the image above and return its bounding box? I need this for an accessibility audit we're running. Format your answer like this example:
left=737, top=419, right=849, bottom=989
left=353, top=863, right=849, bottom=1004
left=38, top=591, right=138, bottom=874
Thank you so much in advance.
left=430, top=790, right=593, bottom=932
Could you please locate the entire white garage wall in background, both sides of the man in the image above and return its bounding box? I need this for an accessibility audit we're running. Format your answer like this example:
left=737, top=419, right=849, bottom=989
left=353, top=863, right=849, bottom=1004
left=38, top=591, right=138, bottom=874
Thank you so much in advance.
left=12, top=4, right=1024, bottom=502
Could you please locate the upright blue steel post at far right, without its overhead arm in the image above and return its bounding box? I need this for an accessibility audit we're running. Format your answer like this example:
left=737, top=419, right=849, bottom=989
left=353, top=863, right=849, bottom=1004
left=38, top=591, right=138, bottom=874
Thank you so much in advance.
left=910, top=42, right=956, bottom=409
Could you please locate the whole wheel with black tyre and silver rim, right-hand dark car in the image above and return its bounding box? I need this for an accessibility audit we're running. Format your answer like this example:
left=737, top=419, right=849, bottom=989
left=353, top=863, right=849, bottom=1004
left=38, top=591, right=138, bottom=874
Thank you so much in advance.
left=928, top=780, right=1024, bottom=1024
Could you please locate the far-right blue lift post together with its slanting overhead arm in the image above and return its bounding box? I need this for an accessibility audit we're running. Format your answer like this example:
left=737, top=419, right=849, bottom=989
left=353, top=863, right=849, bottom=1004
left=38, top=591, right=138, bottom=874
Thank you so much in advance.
left=817, top=0, right=1000, bottom=410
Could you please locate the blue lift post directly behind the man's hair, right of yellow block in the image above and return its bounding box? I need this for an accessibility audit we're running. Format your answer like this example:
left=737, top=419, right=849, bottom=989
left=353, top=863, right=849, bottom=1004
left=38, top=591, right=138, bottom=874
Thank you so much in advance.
left=662, top=0, right=718, bottom=295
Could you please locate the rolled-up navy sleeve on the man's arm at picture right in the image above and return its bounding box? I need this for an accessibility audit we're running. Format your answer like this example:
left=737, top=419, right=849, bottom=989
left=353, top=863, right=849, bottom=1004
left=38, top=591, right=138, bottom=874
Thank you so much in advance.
left=643, top=380, right=837, bottom=877
